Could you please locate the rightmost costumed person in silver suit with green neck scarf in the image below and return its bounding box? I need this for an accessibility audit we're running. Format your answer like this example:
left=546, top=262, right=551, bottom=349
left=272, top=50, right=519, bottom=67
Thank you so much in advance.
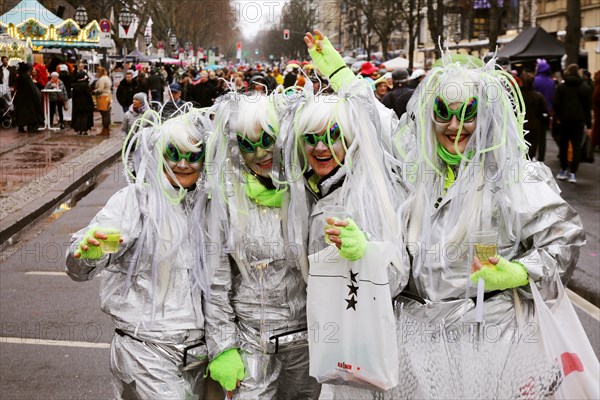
left=396, top=51, right=585, bottom=398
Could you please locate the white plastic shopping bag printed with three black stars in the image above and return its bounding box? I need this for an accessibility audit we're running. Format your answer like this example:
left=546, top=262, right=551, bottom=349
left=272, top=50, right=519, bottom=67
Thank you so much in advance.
left=307, top=242, right=398, bottom=390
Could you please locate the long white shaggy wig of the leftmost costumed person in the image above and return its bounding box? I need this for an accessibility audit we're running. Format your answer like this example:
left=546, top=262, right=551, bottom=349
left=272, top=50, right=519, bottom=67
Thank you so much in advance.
left=123, top=110, right=212, bottom=318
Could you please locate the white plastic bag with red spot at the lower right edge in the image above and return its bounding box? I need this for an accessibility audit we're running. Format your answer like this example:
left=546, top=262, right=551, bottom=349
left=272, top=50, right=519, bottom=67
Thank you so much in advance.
left=530, top=281, right=600, bottom=399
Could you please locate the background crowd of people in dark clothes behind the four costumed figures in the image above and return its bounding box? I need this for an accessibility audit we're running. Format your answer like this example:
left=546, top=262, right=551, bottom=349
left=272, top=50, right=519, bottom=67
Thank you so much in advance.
left=1, top=47, right=600, bottom=183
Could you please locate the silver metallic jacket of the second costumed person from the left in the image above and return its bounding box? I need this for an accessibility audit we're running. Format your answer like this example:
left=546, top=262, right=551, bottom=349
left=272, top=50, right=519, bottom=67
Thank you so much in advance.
left=205, top=200, right=306, bottom=358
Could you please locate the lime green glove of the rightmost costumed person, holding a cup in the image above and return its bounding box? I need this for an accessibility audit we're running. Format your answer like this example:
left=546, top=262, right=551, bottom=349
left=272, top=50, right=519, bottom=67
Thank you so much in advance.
left=470, top=256, right=529, bottom=290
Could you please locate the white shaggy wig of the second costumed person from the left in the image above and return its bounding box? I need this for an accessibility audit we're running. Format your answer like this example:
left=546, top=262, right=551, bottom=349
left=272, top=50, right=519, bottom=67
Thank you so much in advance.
left=203, top=92, right=287, bottom=282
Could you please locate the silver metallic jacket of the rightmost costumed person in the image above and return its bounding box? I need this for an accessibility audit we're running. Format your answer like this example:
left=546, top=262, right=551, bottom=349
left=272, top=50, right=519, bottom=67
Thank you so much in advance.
left=400, top=163, right=585, bottom=312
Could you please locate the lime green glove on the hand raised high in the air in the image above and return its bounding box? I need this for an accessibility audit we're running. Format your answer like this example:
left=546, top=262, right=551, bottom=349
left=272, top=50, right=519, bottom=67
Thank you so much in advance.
left=308, top=38, right=355, bottom=92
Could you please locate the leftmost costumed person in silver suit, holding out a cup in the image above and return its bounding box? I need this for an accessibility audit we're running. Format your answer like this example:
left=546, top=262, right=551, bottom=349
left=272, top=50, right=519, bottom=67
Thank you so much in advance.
left=66, top=111, right=212, bottom=399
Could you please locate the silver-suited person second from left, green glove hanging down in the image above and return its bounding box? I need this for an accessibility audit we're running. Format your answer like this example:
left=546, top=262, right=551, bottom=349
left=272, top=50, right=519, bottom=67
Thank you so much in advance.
left=204, top=92, right=320, bottom=399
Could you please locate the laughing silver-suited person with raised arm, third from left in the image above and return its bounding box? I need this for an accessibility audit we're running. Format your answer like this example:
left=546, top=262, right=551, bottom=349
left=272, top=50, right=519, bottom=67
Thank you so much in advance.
left=274, top=30, right=408, bottom=398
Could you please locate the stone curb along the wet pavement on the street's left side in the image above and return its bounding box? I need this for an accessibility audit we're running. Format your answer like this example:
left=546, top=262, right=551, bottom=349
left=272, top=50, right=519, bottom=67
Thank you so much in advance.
left=0, top=141, right=122, bottom=246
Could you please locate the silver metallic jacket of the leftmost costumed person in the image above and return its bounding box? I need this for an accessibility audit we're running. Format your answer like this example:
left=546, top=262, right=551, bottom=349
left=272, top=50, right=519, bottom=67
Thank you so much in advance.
left=67, top=186, right=204, bottom=344
